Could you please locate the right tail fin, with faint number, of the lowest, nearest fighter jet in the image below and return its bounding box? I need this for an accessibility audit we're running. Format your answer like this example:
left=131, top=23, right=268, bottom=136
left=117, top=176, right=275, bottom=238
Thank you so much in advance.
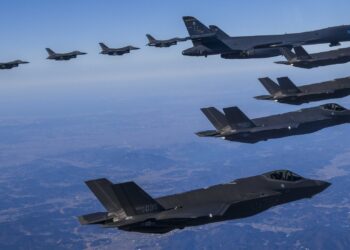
left=113, top=182, right=164, bottom=216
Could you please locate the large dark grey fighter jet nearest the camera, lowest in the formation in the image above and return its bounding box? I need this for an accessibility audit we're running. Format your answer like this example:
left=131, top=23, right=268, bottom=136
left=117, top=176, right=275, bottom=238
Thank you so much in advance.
left=79, top=170, right=331, bottom=234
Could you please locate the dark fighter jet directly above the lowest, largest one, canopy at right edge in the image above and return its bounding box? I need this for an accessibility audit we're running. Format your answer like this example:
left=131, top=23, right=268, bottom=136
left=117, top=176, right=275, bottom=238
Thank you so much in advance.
left=197, top=103, right=350, bottom=143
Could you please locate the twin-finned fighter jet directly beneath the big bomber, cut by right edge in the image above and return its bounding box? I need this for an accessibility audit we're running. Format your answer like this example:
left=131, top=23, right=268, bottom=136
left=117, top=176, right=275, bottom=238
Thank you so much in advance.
left=275, top=46, right=350, bottom=69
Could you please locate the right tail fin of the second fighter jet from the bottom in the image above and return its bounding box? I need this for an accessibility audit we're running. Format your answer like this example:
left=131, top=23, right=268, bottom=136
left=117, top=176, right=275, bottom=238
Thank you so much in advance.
left=224, top=107, right=255, bottom=129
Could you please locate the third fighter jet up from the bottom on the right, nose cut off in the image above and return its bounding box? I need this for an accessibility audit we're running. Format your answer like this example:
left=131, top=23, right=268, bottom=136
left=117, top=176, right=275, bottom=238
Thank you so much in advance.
left=255, top=77, right=350, bottom=105
